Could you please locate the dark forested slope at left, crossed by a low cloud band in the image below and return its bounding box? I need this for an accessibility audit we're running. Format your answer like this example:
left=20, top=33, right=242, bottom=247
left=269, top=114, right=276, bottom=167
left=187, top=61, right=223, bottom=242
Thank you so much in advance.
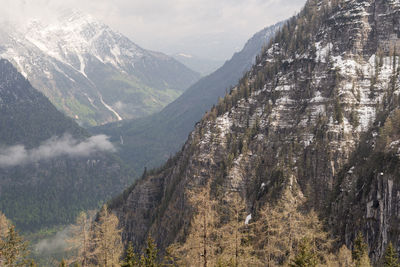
left=0, top=60, right=134, bottom=232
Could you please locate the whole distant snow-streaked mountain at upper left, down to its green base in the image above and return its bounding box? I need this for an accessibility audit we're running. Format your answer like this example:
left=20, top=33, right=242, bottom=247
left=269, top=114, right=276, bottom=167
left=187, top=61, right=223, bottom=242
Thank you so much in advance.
left=0, top=11, right=200, bottom=125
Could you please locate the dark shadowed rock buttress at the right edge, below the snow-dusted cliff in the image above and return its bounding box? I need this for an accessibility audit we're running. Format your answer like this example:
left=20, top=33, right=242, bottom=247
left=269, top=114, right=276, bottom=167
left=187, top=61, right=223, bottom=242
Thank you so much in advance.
left=331, top=110, right=400, bottom=260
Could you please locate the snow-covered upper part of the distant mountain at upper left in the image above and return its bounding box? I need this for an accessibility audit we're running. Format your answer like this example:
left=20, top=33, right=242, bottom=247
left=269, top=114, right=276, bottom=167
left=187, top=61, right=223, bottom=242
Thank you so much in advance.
left=25, top=11, right=143, bottom=76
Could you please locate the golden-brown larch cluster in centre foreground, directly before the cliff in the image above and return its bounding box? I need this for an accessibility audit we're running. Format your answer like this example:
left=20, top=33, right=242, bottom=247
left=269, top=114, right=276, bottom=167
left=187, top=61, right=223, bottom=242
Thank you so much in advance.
left=159, top=185, right=376, bottom=267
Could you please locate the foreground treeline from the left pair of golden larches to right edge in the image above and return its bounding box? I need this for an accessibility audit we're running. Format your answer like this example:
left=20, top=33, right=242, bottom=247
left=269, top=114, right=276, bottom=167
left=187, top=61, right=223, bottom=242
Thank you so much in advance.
left=60, top=184, right=400, bottom=267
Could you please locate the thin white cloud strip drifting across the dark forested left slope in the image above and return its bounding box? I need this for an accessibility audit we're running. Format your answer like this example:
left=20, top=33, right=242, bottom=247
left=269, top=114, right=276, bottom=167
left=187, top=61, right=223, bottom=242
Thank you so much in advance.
left=0, top=135, right=115, bottom=167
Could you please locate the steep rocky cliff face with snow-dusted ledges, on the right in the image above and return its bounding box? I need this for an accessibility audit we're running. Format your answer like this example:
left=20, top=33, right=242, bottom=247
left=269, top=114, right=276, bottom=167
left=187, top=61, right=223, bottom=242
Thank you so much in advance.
left=112, top=0, right=400, bottom=260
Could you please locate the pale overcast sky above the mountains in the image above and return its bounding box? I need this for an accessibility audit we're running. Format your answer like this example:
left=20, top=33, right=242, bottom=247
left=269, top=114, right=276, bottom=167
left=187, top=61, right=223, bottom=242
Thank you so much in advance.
left=0, top=0, right=305, bottom=59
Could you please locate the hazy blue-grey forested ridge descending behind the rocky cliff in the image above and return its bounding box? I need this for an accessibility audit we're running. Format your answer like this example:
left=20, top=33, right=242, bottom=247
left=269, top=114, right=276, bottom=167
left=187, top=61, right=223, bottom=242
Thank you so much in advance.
left=90, top=22, right=283, bottom=170
